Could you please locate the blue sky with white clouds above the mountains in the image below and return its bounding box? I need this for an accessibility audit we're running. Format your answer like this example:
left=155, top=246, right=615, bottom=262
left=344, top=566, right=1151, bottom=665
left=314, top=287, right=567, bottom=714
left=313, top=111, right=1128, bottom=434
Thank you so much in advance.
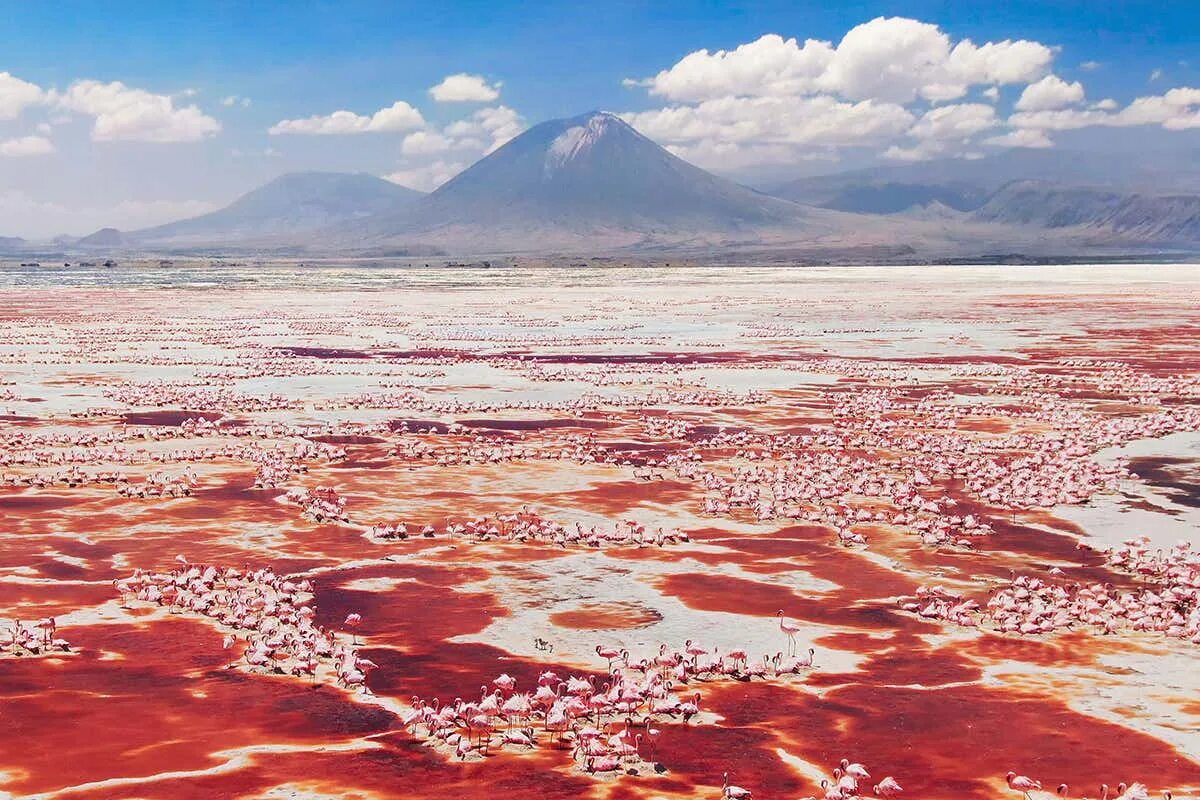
left=0, top=0, right=1200, bottom=235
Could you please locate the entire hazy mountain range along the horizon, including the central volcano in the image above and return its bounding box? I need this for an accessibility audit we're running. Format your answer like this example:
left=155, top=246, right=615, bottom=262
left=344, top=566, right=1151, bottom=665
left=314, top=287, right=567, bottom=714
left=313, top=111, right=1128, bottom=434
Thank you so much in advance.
left=70, top=112, right=1200, bottom=256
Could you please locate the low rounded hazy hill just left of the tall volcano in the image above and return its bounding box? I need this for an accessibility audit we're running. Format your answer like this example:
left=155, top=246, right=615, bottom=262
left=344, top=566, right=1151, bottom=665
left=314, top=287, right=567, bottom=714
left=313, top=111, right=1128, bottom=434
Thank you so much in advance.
left=128, top=173, right=424, bottom=246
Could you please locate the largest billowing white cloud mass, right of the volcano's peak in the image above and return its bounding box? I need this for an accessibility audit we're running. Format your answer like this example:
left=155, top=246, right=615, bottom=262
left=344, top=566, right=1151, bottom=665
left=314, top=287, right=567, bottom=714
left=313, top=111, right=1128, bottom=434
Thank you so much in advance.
left=623, top=17, right=1054, bottom=169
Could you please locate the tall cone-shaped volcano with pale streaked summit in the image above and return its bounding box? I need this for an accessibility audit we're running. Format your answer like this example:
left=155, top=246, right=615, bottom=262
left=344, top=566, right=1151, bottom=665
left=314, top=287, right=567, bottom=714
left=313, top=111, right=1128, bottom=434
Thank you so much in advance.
left=344, top=112, right=828, bottom=249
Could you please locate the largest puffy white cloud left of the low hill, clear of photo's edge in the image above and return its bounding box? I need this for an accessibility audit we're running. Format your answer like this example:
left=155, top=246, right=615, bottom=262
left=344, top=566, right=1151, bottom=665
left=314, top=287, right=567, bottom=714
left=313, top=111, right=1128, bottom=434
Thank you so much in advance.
left=53, top=80, right=221, bottom=142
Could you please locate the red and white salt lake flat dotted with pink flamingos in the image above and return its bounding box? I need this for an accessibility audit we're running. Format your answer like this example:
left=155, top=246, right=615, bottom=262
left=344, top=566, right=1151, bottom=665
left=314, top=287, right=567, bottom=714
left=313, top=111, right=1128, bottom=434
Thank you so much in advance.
left=0, top=265, right=1200, bottom=800
